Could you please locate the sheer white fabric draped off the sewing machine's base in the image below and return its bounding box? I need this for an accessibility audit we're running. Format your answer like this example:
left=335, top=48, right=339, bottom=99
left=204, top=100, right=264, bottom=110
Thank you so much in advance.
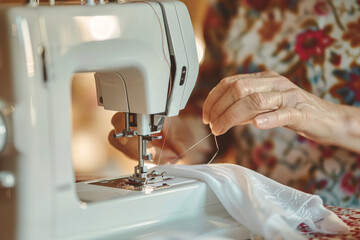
left=155, top=164, right=349, bottom=239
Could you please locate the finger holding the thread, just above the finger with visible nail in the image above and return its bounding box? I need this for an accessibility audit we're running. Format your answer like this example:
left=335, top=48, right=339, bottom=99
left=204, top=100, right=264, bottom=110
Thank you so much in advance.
left=211, top=92, right=288, bottom=135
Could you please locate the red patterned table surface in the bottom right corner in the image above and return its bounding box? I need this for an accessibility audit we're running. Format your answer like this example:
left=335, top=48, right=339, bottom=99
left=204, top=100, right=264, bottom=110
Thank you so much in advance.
left=299, top=206, right=360, bottom=240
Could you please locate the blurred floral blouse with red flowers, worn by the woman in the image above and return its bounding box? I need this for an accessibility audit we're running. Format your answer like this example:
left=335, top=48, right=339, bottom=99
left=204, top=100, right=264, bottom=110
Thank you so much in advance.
left=192, top=0, right=360, bottom=207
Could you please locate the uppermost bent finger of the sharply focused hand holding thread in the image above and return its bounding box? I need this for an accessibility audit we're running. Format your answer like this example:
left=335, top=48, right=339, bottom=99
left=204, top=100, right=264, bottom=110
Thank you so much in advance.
left=203, top=72, right=291, bottom=124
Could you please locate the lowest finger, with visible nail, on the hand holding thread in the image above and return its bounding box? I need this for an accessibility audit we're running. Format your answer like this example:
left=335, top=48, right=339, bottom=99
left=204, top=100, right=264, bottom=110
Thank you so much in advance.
left=253, top=107, right=309, bottom=131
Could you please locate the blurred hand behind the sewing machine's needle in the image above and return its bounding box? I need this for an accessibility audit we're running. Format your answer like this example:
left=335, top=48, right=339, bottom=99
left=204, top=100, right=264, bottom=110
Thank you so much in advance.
left=108, top=113, right=213, bottom=164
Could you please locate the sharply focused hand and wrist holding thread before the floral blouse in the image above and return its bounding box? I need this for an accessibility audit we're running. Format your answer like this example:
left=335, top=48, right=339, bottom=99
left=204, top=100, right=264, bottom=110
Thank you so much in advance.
left=203, top=71, right=360, bottom=152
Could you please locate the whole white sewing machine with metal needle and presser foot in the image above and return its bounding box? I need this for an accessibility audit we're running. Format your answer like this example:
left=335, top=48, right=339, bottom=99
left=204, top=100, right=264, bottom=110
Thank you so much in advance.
left=0, top=0, right=246, bottom=240
